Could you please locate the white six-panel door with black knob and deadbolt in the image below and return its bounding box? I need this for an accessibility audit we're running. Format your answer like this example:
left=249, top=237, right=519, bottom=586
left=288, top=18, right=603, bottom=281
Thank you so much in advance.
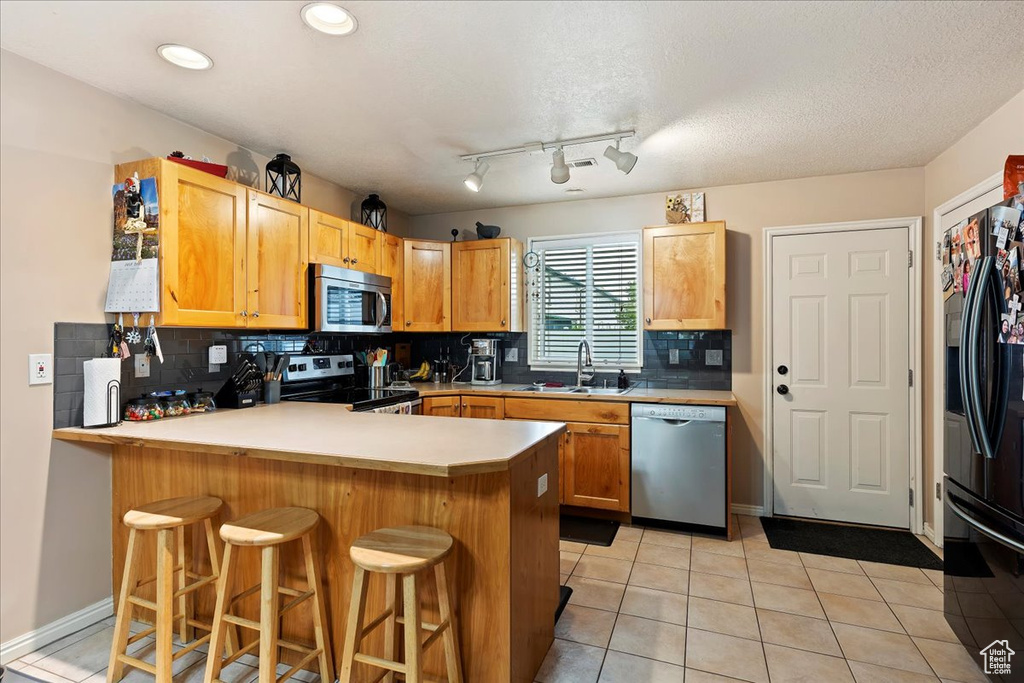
left=766, top=227, right=910, bottom=528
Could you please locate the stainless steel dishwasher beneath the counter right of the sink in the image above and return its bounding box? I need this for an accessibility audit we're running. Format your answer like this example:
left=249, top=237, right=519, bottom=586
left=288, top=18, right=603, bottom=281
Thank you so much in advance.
left=630, top=403, right=727, bottom=530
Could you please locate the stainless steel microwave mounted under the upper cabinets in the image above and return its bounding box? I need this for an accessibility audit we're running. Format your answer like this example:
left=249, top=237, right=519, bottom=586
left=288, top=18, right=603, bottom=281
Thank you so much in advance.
left=312, top=265, right=391, bottom=334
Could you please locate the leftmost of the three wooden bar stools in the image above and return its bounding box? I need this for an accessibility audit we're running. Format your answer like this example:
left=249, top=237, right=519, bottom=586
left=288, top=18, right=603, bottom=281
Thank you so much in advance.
left=106, top=497, right=227, bottom=683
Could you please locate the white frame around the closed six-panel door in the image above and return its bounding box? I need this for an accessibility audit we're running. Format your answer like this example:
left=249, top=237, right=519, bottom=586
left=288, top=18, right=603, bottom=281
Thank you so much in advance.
left=762, top=216, right=925, bottom=533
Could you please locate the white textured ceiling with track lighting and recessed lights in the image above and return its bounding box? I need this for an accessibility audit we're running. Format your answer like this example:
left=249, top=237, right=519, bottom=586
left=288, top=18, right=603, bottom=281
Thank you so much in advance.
left=0, top=0, right=1024, bottom=214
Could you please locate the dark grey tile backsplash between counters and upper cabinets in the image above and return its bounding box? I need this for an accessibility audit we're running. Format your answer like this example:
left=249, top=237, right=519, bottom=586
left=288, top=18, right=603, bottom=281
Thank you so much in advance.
left=53, top=323, right=732, bottom=427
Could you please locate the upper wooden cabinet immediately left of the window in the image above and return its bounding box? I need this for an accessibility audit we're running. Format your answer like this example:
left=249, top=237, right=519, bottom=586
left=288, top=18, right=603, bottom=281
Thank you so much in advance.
left=452, top=238, right=525, bottom=332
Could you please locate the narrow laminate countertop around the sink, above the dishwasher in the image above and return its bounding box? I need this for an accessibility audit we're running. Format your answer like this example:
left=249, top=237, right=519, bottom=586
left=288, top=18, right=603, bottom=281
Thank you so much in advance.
left=413, top=382, right=736, bottom=407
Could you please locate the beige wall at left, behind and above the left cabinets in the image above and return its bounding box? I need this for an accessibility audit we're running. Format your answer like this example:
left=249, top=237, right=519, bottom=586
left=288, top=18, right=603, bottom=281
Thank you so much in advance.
left=0, top=51, right=407, bottom=642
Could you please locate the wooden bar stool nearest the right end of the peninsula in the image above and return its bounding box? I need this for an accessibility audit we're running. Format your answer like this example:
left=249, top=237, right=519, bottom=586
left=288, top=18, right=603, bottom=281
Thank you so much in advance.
left=339, top=526, right=462, bottom=683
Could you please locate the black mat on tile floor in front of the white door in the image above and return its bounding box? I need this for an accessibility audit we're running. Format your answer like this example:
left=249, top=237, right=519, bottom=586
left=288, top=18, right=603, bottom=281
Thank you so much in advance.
left=761, top=517, right=942, bottom=571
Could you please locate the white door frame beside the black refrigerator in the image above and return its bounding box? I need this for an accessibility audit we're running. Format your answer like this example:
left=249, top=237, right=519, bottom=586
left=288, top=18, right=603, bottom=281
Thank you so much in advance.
left=924, top=173, right=1002, bottom=548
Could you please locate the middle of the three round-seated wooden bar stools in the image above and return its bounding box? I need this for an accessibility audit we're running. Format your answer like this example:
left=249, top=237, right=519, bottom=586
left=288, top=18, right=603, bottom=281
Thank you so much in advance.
left=204, top=508, right=334, bottom=683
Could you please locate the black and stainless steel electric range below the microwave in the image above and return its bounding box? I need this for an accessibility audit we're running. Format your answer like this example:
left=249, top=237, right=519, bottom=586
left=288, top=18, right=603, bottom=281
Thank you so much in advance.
left=281, top=354, right=423, bottom=414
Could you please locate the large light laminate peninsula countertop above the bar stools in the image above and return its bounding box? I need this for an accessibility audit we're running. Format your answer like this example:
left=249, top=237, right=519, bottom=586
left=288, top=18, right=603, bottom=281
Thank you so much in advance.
left=53, top=402, right=565, bottom=476
